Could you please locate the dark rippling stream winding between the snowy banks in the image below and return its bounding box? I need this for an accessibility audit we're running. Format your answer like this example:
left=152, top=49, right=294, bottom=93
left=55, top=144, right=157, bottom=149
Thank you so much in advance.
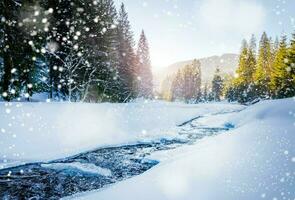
left=0, top=115, right=233, bottom=199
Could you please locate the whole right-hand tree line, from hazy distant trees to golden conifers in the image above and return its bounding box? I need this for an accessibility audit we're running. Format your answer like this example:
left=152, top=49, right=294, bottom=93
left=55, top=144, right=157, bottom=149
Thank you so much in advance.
left=161, top=32, right=295, bottom=103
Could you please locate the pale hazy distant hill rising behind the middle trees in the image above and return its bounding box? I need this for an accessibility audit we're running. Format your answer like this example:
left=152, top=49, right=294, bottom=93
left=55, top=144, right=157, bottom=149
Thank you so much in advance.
left=154, top=54, right=239, bottom=89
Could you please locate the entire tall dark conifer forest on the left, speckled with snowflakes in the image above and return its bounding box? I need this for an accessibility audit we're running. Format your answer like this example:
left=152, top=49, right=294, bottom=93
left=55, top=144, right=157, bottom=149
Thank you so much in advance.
left=0, top=0, right=153, bottom=102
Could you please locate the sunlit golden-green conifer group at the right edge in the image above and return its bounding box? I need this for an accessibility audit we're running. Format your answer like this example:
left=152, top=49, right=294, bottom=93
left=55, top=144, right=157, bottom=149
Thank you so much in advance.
left=224, top=32, right=295, bottom=103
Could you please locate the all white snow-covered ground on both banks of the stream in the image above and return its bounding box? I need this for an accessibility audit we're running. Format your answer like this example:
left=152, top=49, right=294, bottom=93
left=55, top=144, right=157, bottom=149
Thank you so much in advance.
left=0, top=98, right=295, bottom=200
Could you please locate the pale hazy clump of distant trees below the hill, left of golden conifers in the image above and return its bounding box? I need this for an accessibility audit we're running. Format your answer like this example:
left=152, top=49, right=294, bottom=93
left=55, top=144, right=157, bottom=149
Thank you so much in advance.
left=160, top=59, right=224, bottom=103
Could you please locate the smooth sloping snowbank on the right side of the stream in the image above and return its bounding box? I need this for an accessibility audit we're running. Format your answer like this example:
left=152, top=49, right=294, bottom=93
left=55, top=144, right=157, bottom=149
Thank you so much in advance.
left=71, top=99, right=295, bottom=200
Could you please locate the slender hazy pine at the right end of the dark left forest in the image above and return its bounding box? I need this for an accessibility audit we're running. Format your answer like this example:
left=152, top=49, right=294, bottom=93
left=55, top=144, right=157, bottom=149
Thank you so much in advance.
left=136, top=31, right=153, bottom=98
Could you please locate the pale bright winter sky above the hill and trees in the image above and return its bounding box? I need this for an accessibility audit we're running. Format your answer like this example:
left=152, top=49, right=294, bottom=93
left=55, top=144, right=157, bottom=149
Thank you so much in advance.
left=115, top=0, right=295, bottom=70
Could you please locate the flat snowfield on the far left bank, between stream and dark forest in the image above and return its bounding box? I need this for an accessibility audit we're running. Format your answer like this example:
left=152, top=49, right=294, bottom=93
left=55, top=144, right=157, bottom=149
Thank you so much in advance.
left=0, top=101, right=243, bottom=168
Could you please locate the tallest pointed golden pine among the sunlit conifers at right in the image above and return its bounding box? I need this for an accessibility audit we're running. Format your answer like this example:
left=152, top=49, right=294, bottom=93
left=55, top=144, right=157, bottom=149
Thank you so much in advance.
left=254, top=32, right=272, bottom=98
